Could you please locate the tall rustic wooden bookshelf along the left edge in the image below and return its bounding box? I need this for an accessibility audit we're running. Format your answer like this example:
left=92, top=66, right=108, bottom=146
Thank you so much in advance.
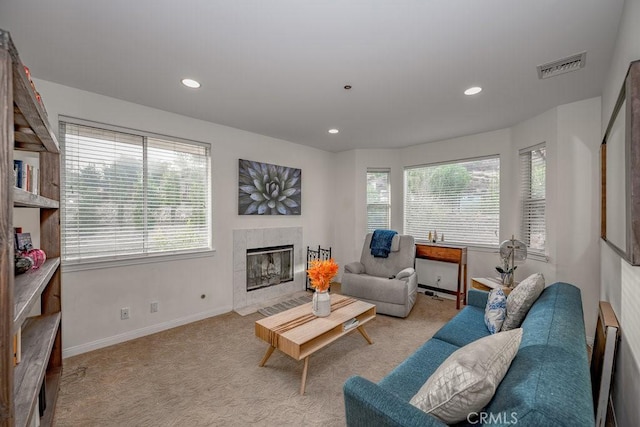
left=0, top=30, right=62, bottom=427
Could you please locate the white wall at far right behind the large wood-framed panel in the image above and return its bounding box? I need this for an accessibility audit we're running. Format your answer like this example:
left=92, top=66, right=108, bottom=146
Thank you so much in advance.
left=600, top=0, right=640, bottom=426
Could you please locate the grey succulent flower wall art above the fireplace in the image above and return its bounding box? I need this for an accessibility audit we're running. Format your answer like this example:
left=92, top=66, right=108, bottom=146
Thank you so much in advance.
left=238, top=159, right=302, bottom=215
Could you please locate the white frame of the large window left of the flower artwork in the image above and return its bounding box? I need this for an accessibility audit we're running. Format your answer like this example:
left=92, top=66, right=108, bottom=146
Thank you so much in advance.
left=58, top=115, right=216, bottom=271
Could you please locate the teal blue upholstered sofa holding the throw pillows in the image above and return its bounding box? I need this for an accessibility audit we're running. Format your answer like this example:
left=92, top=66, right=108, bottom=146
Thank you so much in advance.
left=344, top=283, right=594, bottom=427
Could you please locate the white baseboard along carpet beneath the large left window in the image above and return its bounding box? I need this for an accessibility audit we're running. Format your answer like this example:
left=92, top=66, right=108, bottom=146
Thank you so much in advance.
left=62, top=306, right=233, bottom=359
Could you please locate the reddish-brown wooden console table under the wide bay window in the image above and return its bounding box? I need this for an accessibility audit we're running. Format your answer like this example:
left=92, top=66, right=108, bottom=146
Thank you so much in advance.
left=416, top=243, right=467, bottom=310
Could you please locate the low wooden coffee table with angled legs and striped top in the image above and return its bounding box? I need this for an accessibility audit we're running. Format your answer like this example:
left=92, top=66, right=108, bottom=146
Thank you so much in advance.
left=256, top=294, right=376, bottom=394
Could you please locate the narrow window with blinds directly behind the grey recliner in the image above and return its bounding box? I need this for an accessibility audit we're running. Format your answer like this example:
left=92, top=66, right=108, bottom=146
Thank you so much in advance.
left=367, top=169, right=391, bottom=233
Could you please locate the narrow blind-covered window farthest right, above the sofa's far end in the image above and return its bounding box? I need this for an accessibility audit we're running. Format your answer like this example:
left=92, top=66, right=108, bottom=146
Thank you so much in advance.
left=520, top=144, right=547, bottom=255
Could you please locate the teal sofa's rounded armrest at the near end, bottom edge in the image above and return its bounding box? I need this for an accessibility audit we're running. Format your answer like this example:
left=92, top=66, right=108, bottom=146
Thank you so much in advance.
left=343, top=376, right=446, bottom=427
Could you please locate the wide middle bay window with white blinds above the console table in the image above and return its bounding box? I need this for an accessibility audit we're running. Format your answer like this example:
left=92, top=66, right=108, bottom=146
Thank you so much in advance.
left=404, top=156, right=500, bottom=246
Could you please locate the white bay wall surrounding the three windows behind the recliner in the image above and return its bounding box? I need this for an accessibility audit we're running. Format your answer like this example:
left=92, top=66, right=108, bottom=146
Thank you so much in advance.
left=336, top=98, right=600, bottom=341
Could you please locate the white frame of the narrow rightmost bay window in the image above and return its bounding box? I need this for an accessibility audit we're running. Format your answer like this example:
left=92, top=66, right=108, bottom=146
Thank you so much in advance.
left=518, top=142, right=549, bottom=261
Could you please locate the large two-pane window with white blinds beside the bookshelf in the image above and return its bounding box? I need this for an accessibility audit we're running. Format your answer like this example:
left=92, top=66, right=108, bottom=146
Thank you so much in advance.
left=60, top=118, right=211, bottom=263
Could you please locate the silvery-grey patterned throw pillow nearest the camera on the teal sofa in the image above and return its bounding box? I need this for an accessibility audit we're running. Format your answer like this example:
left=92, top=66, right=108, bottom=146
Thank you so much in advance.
left=410, top=329, right=522, bottom=424
